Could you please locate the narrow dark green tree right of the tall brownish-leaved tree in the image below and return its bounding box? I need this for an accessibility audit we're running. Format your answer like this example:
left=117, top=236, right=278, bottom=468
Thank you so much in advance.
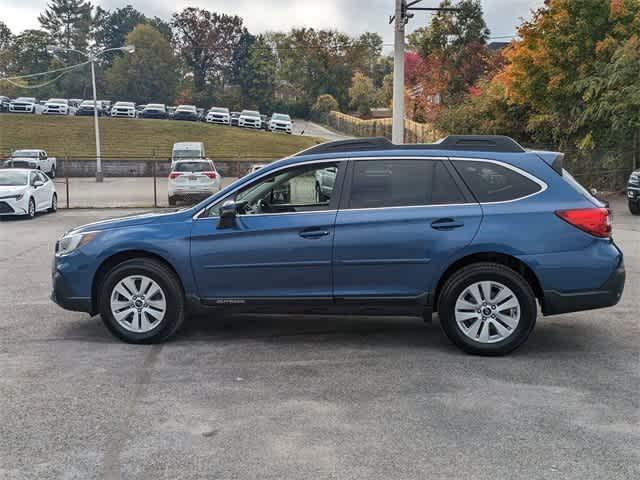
left=237, top=35, right=276, bottom=110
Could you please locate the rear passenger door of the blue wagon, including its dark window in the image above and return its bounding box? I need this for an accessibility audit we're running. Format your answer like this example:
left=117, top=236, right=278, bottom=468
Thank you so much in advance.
left=333, top=158, right=482, bottom=302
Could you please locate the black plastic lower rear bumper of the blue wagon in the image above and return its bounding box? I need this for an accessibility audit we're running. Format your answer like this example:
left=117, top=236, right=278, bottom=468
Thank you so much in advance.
left=542, top=258, right=626, bottom=316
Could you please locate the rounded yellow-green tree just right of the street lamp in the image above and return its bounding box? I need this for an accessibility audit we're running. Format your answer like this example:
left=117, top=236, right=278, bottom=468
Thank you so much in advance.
left=105, top=25, right=178, bottom=103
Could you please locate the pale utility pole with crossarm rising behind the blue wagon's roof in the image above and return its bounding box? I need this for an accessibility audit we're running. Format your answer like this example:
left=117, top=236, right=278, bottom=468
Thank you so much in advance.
left=389, top=0, right=458, bottom=144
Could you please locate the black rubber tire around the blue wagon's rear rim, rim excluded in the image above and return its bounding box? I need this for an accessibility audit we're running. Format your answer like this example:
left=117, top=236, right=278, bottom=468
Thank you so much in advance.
left=438, top=264, right=538, bottom=355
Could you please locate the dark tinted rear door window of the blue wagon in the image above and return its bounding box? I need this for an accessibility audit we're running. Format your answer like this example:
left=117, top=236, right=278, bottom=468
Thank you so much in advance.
left=349, top=159, right=464, bottom=209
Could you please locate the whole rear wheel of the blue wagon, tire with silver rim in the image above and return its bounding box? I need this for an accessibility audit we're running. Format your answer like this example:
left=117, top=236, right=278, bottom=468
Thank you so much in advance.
left=438, top=263, right=537, bottom=356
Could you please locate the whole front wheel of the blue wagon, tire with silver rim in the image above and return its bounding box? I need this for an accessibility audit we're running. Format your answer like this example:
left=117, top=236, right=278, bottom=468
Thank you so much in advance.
left=99, top=258, right=185, bottom=344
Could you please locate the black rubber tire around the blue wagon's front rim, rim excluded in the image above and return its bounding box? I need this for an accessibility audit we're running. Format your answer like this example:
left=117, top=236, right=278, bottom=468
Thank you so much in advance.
left=98, top=259, right=184, bottom=344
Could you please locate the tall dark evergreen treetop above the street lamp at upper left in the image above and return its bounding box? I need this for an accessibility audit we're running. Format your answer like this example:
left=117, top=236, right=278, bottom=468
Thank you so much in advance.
left=38, top=0, right=93, bottom=50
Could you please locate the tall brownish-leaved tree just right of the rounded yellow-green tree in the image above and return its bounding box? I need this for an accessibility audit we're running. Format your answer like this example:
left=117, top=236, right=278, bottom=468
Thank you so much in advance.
left=171, top=7, right=244, bottom=92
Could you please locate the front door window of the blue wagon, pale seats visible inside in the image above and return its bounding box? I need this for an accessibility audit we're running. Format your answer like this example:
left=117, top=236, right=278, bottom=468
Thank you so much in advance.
left=206, top=162, right=338, bottom=217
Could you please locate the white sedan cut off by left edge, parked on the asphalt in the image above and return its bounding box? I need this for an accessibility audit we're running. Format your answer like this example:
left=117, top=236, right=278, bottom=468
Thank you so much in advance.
left=0, top=168, right=58, bottom=218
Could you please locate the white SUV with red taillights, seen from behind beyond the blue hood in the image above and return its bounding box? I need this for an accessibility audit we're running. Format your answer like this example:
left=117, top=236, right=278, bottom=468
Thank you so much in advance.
left=168, top=160, right=222, bottom=205
